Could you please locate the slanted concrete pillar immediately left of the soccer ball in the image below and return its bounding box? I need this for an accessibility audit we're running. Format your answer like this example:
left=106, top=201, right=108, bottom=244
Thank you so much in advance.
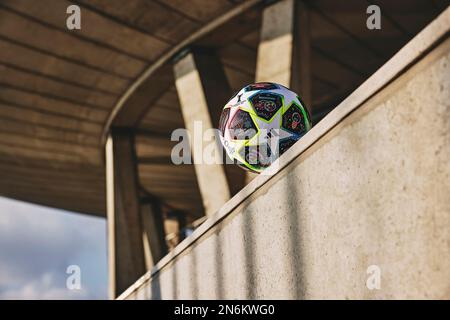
left=174, top=49, right=237, bottom=215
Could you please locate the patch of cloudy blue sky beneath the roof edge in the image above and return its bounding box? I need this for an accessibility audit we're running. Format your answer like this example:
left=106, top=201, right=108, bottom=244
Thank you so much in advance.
left=0, top=197, right=107, bottom=299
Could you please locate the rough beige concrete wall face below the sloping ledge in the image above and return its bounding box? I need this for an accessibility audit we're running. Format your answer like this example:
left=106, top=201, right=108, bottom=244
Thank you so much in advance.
left=128, top=40, right=450, bottom=299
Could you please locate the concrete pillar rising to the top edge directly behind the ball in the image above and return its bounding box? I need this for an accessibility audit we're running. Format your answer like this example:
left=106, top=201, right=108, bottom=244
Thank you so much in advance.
left=256, top=0, right=312, bottom=111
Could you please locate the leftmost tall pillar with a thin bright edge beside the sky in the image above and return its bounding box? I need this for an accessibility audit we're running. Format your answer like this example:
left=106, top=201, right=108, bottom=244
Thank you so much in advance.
left=105, top=130, right=146, bottom=298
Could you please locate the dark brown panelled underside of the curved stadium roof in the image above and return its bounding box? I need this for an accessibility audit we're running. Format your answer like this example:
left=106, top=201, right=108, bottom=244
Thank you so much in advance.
left=0, top=0, right=448, bottom=217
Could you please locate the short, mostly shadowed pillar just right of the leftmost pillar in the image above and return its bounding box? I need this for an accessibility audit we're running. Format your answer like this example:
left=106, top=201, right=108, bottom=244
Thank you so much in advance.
left=141, top=199, right=168, bottom=270
